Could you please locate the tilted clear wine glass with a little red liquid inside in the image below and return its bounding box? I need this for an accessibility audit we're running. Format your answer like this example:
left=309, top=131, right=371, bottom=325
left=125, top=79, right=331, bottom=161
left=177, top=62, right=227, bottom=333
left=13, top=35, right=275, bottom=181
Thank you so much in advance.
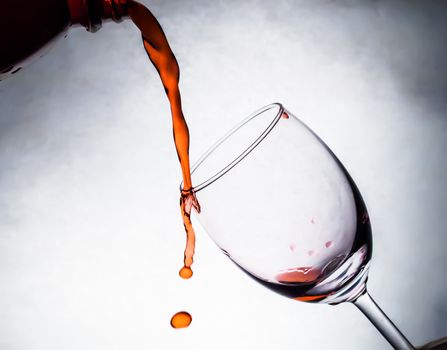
left=185, top=103, right=447, bottom=349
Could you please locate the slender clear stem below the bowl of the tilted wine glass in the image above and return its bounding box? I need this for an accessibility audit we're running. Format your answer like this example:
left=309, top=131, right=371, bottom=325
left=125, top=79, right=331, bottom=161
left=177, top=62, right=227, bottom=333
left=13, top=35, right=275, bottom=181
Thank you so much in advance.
left=353, top=291, right=416, bottom=350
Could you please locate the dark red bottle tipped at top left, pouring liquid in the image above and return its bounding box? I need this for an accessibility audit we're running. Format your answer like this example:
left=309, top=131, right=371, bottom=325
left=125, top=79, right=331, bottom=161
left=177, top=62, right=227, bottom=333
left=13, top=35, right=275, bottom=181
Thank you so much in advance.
left=0, top=0, right=127, bottom=80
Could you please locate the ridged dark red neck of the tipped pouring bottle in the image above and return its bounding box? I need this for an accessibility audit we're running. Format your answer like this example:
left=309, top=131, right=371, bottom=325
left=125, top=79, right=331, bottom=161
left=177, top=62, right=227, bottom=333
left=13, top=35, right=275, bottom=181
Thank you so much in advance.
left=67, top=0, right=128, bottom=33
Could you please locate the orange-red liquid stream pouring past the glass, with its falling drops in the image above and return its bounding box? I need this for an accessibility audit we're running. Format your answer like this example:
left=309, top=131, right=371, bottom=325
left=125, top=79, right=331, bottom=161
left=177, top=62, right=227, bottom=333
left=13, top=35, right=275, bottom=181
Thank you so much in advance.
left=128, top=0, right=200, bottom=328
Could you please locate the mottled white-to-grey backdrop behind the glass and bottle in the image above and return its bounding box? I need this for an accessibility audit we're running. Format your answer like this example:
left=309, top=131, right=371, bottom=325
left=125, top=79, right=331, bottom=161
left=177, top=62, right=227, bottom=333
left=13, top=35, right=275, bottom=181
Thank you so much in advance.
left=0, top=0, right=447, bottom=350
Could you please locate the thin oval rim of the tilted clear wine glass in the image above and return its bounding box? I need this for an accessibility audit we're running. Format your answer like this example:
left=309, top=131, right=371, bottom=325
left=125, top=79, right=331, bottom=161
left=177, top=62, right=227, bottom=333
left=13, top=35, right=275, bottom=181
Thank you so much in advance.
left=184, top=102, right=285, bottom=192
